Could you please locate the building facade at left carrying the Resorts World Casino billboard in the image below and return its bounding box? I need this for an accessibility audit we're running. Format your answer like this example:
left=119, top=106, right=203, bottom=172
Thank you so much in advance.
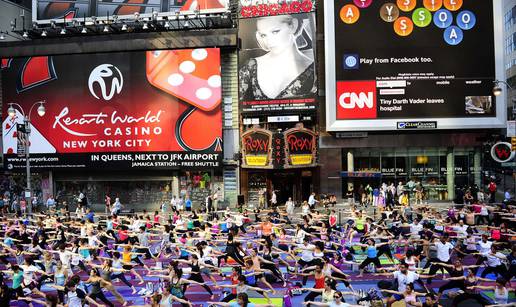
left=1, top=2, right=239, bottom=210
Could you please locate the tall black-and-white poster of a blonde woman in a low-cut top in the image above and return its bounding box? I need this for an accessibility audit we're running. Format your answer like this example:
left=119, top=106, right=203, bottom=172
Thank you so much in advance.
left=238, top=13, right=317, bottom=114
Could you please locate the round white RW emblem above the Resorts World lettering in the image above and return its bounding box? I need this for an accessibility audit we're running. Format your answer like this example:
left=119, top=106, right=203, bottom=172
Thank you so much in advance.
left=88, top=64, right=124, bottom=101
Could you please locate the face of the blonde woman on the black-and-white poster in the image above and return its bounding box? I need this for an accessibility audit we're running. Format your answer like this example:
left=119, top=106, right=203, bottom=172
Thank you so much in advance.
left=256, top=16, right=297, bottom=54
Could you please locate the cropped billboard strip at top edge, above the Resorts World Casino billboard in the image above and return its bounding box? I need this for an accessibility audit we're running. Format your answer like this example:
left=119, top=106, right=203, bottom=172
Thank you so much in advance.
left=33, top=0, right=228, bottom=21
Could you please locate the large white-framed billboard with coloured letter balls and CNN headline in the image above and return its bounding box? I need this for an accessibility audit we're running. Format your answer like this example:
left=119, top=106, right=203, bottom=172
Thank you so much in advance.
left=324, top=0, right=506, bottom=131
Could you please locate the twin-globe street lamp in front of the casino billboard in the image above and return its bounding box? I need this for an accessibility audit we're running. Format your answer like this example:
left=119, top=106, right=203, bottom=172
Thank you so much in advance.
left=7, top=100, right=46, bottom=214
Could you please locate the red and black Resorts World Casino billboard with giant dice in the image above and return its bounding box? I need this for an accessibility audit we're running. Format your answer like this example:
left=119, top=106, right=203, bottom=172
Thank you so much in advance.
left=2, top=48, right=222, bottom=169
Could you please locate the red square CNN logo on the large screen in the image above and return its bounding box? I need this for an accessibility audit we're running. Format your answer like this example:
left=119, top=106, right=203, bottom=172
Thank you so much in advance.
left=337, top=81, right=377, bottom=119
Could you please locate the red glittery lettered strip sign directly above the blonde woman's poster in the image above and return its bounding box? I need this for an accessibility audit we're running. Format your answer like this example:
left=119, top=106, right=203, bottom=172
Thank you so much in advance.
left=239, top=0, right=315, bottom=18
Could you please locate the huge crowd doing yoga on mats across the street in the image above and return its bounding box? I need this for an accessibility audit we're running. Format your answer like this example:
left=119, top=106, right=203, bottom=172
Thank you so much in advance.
left=0, top=182, right=516, bottom=307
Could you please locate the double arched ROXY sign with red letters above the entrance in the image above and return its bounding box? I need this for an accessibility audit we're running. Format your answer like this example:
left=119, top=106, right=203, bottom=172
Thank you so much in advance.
left=242, top=124, right=317, bottom=169
